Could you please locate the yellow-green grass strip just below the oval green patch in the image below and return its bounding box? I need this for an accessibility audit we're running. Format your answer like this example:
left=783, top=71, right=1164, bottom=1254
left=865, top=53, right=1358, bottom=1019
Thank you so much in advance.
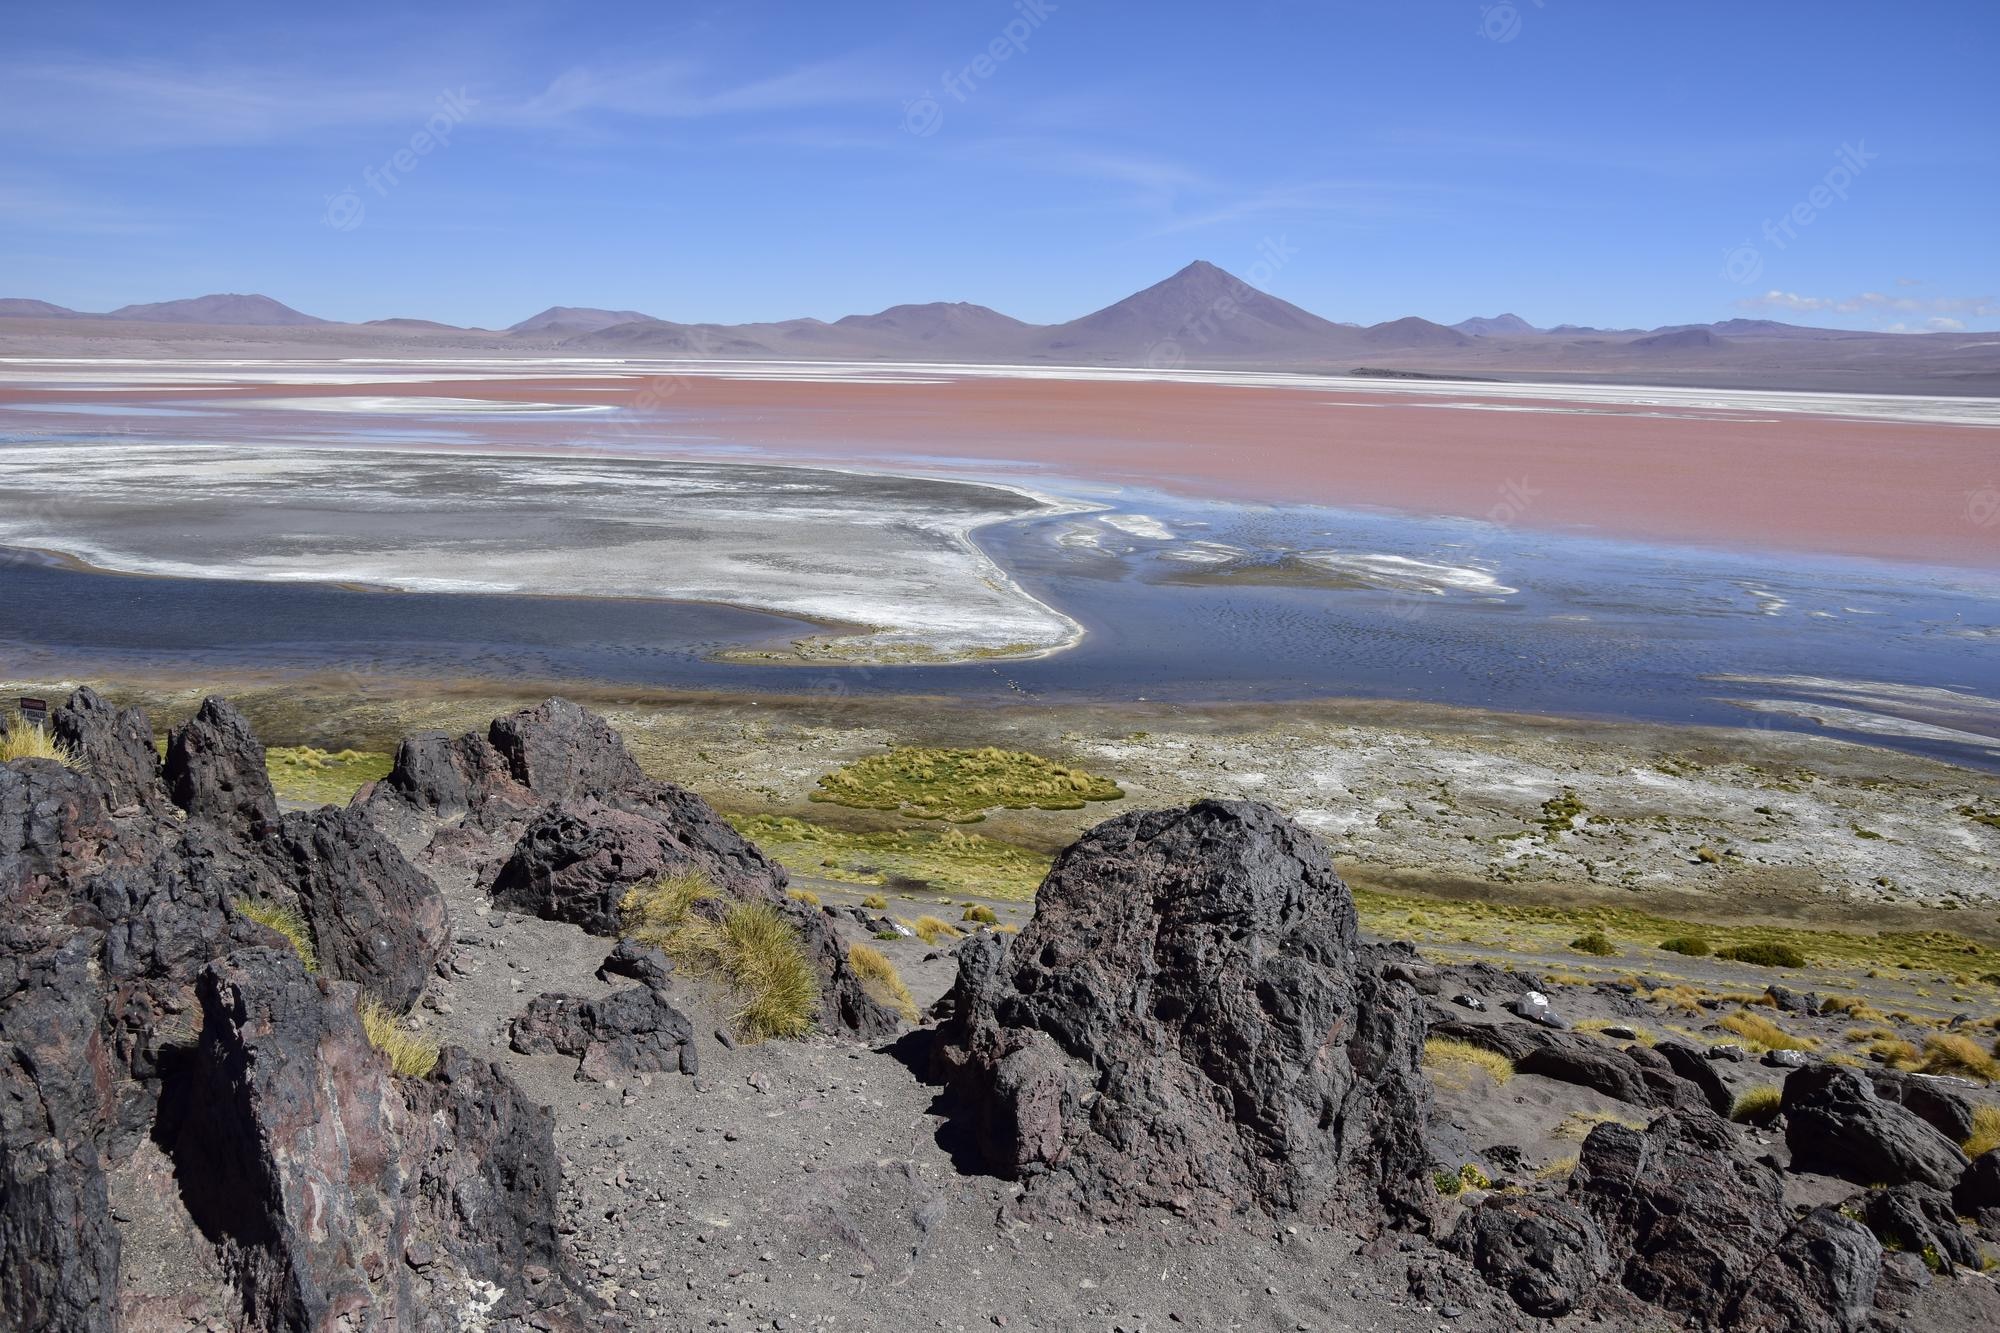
left=730, top=815, right=1048, bottom=899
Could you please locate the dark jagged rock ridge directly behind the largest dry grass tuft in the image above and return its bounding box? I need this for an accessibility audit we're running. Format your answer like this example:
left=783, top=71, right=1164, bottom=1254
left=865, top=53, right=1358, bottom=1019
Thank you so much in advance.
left=354, top=699, right=898, bottom=1037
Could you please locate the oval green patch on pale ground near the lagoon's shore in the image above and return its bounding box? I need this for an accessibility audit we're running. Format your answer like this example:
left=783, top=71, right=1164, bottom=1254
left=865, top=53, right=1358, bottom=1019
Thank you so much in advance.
left=812, top=745, right=1124, bottom=825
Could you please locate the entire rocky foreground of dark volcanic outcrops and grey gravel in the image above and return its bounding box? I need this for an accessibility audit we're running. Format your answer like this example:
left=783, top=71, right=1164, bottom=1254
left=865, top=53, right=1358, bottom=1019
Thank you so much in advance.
left=0, top=691, right=2000, bottom=1331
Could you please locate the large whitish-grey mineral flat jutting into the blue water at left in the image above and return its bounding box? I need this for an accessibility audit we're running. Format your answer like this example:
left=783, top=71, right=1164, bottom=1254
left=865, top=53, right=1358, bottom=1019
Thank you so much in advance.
left=0, top=444, right=1082, bottom=662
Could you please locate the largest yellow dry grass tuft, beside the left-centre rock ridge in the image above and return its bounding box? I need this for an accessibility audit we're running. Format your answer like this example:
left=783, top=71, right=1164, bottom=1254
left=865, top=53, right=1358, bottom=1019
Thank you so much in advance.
left=618, top=871, right=820, bottom=1041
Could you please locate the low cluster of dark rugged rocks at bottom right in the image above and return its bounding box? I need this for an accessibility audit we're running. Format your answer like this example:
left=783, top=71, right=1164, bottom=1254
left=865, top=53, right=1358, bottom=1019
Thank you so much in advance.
left=1448, top=1109, right=1882, bottom=1333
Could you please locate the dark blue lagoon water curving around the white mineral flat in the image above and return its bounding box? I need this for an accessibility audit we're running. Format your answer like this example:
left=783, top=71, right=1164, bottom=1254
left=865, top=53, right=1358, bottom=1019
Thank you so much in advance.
left=0, top=496, right=2000, bottom=769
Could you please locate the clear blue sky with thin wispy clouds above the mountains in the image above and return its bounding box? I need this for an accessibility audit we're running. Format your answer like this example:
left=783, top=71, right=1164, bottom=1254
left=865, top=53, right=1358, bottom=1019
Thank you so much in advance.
left=0, top=0, right=2000, bottom=330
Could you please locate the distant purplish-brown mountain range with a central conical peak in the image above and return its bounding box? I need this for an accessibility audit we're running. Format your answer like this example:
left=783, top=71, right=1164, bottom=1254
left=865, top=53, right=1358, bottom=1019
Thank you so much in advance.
left=0, top=260, right=2000, bottom=394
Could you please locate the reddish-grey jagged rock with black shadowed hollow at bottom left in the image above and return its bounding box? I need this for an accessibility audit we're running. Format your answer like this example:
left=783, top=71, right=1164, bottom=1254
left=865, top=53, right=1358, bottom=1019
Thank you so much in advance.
left=160, top=949, right=584, bottom=1333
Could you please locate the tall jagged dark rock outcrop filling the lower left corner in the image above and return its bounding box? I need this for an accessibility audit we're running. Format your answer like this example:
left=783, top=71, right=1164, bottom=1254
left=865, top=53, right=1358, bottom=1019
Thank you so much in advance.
left=0, top=691, right=590, bottom=1333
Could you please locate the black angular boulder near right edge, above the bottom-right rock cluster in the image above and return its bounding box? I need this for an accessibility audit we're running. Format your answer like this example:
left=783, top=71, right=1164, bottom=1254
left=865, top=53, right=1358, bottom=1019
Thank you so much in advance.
left=1782, top=1065, right=1966, bottom=1191
